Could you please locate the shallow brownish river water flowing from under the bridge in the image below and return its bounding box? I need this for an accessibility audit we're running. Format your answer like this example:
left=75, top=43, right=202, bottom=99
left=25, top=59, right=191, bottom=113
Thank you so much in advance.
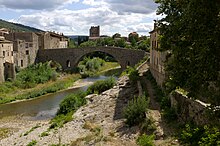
left=0, top=76, right=117, bottom=120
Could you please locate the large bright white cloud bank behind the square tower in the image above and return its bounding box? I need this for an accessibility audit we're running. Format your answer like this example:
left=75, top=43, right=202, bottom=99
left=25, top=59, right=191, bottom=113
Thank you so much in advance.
left=14, top=4, right=156, bottom=36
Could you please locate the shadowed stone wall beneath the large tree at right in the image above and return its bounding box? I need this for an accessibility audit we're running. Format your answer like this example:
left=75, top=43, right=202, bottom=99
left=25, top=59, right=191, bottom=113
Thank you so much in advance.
left=170, top=91, right=217, bottom=125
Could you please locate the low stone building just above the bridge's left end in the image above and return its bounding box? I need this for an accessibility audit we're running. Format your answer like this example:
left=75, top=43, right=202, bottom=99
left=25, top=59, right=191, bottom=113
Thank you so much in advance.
left=37, top=32, right=68, bottom=49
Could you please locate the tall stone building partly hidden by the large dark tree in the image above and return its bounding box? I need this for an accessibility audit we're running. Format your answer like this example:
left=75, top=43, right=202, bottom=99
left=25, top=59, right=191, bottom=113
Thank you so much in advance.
left=150, top=23, right=167, bottom=86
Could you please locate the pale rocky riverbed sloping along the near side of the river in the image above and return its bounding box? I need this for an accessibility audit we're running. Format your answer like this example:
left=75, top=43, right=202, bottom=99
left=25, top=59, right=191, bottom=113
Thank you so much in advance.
left=0, top=76, right=138, bottom=146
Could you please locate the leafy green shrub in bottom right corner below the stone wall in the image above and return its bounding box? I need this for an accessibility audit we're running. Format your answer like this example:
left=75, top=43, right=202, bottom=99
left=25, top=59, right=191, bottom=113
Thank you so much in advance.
left=180, top=124, right=220, bottom=146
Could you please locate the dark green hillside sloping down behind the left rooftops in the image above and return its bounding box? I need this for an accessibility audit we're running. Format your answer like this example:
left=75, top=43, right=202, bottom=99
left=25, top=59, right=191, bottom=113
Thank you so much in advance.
left=0, top=19, right=43, bottom=32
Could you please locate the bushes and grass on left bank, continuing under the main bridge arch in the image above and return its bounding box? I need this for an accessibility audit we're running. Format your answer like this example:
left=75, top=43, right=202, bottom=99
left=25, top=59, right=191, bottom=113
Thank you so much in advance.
left=0, top=58, right=118, bottom=104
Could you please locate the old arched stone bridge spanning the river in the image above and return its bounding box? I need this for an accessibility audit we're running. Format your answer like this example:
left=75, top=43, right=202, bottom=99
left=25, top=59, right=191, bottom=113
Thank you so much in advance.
left=36, top=47, right=146, bottom=70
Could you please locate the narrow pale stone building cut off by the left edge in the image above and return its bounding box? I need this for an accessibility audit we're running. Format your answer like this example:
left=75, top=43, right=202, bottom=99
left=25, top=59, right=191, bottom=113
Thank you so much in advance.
left=0, top=30, right=15, bottom=83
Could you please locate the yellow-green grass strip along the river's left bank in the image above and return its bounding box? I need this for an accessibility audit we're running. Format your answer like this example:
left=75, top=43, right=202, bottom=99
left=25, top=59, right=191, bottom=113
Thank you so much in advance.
left=0, top=74, right=80, bottom=104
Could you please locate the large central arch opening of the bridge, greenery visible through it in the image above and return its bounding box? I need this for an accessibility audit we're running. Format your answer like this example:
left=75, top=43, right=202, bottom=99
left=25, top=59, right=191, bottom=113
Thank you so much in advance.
left=77, top=51, right=121, bottom=77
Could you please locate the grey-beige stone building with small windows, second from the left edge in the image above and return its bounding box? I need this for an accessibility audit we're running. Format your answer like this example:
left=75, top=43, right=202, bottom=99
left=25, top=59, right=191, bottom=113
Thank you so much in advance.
left=5, top=32, right=39, bottom=68
